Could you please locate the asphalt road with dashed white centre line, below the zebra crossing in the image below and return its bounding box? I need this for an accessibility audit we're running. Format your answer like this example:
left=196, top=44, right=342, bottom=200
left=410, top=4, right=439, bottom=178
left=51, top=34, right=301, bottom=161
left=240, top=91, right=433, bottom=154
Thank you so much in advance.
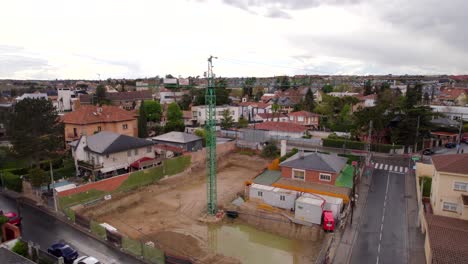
left=351, top=170, right=408, bottom=264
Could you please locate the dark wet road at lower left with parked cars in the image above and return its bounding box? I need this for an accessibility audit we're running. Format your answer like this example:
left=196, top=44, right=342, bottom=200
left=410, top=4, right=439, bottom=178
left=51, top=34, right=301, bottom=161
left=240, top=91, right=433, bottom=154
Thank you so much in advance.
left=0, top=194, right=142, bottom=264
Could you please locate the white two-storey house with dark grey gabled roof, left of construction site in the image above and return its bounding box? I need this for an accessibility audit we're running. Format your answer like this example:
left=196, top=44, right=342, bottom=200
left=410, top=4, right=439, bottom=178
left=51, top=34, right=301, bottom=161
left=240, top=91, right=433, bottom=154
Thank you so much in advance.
left=69, top=131, right=159, bottom=178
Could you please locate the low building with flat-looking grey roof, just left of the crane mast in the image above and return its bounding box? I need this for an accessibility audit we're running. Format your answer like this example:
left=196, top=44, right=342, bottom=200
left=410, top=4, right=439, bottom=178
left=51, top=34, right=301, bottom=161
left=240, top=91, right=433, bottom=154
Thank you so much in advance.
left=151, top=131, right=203, bottom=151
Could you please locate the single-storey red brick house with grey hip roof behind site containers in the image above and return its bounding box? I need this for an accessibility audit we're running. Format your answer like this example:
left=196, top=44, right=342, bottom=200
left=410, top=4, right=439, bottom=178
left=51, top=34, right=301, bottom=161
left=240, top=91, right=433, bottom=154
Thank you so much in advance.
left=280, top=151, right=347, bottom=185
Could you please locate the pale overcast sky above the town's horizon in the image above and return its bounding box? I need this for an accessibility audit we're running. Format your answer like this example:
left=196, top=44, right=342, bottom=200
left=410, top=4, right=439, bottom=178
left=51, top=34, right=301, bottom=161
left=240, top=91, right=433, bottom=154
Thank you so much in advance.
left=0, top=0, right=468, bottom=79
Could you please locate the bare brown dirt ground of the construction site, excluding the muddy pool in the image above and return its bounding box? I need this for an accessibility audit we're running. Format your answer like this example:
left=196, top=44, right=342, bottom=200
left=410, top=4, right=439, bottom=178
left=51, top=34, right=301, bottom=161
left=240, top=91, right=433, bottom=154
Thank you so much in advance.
left=83, top=154, right=268, bottom=263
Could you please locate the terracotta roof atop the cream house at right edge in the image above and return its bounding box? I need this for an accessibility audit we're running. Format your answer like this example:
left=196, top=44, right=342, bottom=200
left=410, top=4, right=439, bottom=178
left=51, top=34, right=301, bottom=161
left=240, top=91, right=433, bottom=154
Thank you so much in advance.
left=432, top=153, right=468, bottom=175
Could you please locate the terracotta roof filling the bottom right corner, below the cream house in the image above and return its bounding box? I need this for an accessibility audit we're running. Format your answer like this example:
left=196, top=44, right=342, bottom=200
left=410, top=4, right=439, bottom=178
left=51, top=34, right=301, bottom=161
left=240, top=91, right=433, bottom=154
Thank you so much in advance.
left=426, top=214, right=468, bottom=264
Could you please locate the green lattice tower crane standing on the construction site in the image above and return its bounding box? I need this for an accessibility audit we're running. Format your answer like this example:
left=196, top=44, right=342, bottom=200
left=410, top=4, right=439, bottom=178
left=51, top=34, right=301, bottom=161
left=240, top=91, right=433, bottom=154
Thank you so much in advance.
left=205, top=56, right=218, bottom=215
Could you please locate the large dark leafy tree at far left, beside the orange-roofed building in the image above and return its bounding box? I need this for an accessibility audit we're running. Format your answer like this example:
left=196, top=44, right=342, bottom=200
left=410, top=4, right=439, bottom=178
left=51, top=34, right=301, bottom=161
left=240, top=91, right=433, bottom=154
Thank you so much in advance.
left=10, top=98, right=64, bottom=164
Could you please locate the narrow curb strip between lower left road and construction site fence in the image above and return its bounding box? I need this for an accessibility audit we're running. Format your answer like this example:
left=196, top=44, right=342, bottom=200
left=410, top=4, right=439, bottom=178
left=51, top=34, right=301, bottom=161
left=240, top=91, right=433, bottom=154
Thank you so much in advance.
left=1, top=192, right=146, bottom=263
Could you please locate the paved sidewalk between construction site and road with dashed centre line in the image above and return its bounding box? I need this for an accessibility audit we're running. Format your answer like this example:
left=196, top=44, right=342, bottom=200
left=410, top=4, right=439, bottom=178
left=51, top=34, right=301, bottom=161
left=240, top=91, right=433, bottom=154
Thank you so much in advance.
left=332, top=167, right=372, bottom=264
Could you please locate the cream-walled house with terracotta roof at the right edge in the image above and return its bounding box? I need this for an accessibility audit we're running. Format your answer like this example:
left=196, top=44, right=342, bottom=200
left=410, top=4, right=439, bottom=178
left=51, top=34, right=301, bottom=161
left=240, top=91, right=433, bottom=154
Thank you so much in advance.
left=431, top=154, right=468, bottom=220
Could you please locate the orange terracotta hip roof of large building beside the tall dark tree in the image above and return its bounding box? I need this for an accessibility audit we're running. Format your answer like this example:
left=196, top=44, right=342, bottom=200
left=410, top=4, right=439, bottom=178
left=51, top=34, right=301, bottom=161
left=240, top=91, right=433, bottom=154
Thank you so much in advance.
left=63, top=105, right=136, bottom=125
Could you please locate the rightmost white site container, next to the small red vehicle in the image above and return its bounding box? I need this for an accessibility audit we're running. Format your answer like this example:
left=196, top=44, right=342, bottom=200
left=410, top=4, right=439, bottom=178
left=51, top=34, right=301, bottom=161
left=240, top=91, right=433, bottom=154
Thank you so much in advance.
left=294, top=196, right=325, bottom=225
